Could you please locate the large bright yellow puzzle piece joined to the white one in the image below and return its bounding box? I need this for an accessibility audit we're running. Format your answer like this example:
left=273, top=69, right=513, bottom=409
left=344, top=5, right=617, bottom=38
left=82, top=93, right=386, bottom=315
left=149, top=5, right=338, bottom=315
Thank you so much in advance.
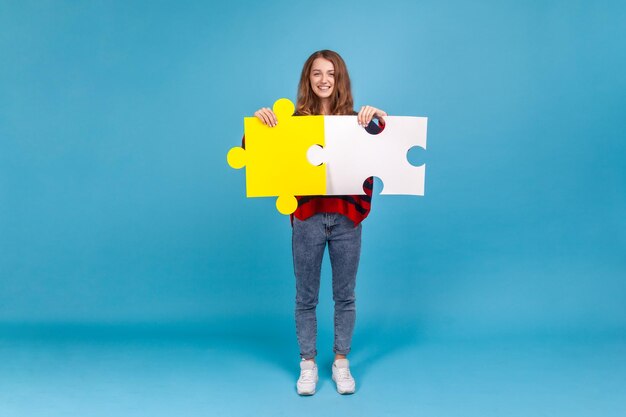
left=227, top=98, right=326, bottom=214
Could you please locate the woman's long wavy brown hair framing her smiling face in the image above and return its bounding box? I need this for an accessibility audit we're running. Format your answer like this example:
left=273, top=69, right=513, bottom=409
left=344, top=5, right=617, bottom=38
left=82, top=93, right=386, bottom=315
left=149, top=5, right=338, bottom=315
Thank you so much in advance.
left=296, top=49, right=354, bottom=116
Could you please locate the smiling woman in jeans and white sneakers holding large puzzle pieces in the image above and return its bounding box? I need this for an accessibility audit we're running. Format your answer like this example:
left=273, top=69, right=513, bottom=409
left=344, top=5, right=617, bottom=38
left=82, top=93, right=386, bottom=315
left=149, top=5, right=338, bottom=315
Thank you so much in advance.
left=255, top=50, right=387, bottom=395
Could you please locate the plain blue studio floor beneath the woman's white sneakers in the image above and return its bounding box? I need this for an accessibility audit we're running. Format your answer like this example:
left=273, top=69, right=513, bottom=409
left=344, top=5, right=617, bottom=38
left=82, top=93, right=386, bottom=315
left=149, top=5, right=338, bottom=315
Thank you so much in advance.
left=0, top=324, right=626, bottom=417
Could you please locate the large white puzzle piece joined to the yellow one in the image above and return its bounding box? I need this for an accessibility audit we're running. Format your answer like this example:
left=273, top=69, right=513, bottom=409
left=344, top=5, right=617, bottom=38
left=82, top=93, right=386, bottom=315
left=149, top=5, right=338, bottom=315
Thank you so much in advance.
left=307, top=116, right=428, bottom=195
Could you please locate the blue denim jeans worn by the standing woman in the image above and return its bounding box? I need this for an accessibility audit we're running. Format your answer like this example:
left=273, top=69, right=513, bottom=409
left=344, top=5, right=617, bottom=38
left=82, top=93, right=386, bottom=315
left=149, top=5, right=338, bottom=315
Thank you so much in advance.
left=292, top=213, right=361, bottom=359
